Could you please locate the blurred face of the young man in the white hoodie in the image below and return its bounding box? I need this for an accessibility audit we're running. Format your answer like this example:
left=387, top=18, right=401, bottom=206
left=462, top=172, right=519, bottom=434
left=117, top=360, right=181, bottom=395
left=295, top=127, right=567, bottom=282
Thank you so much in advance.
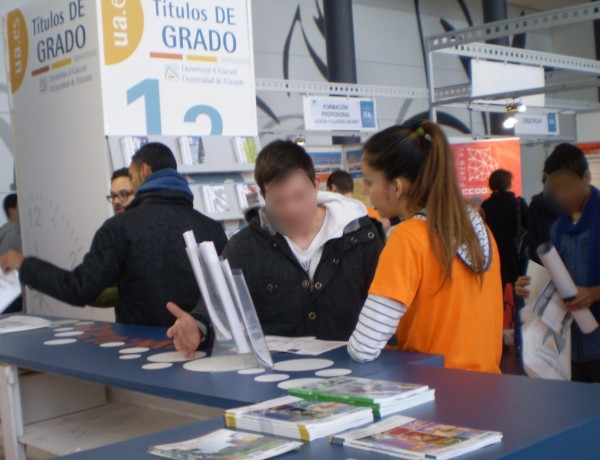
left=264, top=171, right=319, bottom=237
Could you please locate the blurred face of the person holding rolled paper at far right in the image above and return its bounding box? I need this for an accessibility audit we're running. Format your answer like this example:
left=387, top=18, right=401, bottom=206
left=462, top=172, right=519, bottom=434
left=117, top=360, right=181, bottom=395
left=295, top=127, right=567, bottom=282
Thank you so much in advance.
left=546, top=169, right=591, bottom=215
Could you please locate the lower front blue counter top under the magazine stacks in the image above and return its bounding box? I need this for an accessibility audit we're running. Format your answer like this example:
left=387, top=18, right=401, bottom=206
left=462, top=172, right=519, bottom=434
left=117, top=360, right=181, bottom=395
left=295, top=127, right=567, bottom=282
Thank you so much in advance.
left=58, top=366, right=600, bottom=460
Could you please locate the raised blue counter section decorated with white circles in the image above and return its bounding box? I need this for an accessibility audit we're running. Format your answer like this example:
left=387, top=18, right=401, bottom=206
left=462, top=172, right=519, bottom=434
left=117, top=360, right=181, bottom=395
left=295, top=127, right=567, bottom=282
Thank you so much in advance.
left=0, top=321, right=443, bottom=459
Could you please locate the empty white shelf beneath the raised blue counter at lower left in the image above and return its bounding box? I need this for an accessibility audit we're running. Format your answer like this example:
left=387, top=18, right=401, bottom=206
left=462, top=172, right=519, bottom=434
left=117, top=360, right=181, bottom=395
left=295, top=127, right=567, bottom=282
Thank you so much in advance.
left=20, top=403, right=199, bottom=456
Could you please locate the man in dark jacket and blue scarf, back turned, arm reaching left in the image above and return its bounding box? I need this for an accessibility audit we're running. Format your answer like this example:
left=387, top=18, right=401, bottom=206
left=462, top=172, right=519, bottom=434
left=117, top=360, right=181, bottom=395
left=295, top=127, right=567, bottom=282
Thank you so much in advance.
left=0, top=143, right=226, bottom=327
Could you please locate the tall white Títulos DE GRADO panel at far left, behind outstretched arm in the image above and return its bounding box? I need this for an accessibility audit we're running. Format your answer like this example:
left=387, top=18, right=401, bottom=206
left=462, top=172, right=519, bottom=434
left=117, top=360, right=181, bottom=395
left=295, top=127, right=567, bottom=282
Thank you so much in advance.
left=5, top=0, right=114, bottom=319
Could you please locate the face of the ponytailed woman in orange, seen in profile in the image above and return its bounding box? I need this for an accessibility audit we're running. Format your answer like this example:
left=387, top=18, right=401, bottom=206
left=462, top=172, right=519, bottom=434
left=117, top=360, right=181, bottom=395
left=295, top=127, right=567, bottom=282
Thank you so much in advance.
left=362, top=159, right=405, bottom=219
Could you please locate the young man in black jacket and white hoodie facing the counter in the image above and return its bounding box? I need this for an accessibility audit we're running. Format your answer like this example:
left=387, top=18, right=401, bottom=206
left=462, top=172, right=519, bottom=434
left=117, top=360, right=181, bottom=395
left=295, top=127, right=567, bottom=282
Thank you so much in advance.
left=169, top=141, right=384, bottom=356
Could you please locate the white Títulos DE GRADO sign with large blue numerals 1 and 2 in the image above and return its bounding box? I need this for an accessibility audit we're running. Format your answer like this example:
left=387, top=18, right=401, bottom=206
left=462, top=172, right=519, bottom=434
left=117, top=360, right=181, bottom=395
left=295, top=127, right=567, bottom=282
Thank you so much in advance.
left=99, top=0, right=257, bottom=136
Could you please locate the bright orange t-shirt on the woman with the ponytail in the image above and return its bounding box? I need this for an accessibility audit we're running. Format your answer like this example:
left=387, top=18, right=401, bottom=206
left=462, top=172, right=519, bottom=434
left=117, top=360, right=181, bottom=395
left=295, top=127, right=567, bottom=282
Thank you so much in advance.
left=369, top=219, right=503, bottom=373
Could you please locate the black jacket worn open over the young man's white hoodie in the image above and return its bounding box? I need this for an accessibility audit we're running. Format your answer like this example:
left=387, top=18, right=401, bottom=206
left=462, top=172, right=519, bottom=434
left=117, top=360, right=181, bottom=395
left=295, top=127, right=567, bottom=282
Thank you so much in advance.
left=194, top=208, right=383, bottom=340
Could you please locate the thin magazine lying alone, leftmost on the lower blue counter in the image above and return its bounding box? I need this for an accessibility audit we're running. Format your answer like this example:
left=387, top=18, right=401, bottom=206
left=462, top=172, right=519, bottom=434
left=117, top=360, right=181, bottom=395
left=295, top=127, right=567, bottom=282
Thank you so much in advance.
left=148, top=429, right=302, bottom=460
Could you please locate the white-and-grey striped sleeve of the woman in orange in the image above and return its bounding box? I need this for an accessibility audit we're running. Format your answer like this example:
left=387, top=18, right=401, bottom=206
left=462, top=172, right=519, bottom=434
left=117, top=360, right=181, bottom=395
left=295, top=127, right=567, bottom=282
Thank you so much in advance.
left=348, top=294, right=406, bottom=362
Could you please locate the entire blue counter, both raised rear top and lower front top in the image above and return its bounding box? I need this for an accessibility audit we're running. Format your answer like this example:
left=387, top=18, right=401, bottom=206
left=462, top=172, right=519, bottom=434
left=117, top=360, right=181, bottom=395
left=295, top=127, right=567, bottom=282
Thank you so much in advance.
left=0, top=316, right=600, bottom=460
